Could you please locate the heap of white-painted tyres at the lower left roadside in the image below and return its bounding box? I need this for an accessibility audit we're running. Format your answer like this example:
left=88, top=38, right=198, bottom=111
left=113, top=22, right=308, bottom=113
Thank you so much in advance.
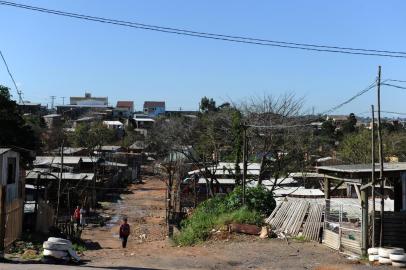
left=42, top=237, right=80, bottom=262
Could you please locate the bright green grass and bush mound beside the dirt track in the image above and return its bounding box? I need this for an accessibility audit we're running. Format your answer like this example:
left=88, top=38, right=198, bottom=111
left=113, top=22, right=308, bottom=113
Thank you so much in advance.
left=173, top=187, right=275, bottom=246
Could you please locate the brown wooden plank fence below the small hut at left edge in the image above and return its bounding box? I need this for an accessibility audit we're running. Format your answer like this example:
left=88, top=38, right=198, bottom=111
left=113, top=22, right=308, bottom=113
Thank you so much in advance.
left=4, top=199, right=24, bottom=246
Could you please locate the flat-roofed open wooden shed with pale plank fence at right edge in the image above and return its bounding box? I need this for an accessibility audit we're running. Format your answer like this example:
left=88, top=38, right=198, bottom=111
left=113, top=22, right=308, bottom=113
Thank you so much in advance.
left=317, top=162, right=406, bottom=255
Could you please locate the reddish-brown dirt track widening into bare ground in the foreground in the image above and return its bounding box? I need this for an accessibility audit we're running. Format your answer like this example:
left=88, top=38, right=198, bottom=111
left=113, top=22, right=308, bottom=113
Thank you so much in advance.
left=0, top=174, right=394, bottom=270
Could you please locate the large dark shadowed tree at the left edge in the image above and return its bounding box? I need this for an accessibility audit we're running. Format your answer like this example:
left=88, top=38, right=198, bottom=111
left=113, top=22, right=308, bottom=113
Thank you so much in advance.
left=0, top=85, right=41, bottom=162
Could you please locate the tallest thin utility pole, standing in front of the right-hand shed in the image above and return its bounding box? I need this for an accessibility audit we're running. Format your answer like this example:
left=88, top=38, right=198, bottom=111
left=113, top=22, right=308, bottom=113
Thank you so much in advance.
left=377, top=66, right=385, bottom=247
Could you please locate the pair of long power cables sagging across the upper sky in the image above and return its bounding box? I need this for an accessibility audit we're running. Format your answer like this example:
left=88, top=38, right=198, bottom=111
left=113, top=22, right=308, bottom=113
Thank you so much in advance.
left=0, top=1, right=406, bottom=58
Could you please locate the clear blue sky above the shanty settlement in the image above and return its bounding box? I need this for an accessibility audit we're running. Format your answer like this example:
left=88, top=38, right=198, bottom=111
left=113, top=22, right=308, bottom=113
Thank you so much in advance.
left=0, top=0, right=406, bottom=113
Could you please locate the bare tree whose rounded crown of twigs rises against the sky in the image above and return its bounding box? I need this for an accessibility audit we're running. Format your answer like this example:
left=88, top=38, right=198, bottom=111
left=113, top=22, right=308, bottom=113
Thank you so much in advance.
left=242, top=94, right=310, bottom=189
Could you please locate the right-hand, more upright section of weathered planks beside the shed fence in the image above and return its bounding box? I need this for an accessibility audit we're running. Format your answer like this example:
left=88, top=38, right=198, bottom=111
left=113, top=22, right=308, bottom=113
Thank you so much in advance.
left=302, top=203, right=324, bottom=241
